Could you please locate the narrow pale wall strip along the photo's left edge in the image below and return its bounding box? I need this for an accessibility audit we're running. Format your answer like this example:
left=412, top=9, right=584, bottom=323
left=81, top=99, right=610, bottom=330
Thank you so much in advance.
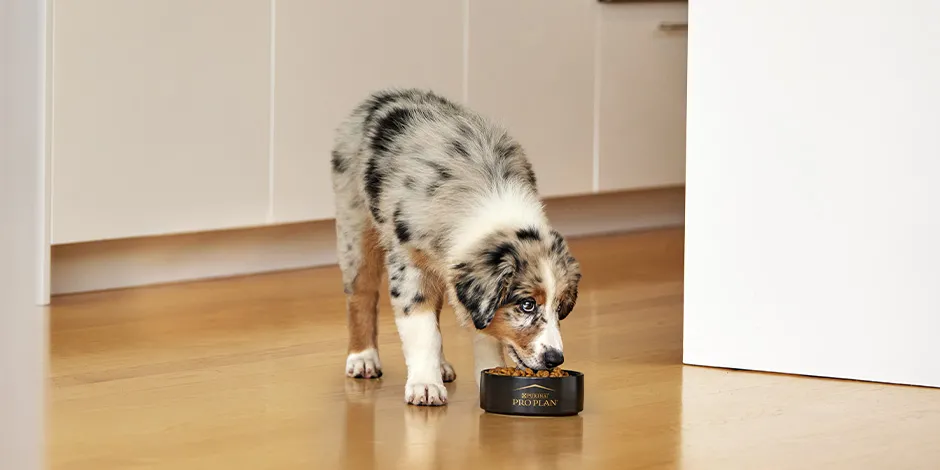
left=0, top=0, right=48, bottom=470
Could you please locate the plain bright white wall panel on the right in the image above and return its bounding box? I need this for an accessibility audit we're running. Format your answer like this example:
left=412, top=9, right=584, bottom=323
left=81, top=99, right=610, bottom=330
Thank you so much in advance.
left=685, top=0, right=940, bottom=386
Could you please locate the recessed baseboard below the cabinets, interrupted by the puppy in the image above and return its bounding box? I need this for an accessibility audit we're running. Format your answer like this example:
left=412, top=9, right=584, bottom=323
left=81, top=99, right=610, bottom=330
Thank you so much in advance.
left=52, top=188, right=685, bottom=295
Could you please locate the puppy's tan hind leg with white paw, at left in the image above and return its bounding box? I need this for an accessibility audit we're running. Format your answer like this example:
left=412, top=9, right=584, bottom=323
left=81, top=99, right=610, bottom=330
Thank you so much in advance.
left=336, top=191, right=384, bottom=379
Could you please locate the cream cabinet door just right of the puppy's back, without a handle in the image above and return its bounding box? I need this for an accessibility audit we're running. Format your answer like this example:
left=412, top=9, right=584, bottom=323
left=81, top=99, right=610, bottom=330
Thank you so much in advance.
left=467, top=0, right=596, bottom=196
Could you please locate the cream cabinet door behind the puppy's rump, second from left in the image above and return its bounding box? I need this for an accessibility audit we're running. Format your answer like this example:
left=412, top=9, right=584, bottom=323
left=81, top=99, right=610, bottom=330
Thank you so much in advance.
left=274, top=0, right=464, bottom=222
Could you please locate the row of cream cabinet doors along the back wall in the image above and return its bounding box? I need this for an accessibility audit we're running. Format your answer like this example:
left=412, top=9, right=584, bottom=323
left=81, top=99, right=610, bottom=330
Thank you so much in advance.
left=48, top=0, right=687, bottom=244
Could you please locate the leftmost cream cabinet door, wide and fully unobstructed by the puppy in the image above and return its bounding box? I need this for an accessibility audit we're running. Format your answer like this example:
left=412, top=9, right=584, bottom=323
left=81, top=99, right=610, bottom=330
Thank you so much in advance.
left=51, top=0, right=270, bottom=243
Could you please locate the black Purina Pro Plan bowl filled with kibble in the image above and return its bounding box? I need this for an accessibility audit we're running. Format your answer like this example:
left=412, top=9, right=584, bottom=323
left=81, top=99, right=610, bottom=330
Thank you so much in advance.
left=480, top=369, right=584, bottom=416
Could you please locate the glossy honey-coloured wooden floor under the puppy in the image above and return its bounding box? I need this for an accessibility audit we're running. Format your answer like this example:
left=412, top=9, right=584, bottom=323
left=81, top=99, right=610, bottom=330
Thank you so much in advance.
left=49, top=230, right=940, bottom=470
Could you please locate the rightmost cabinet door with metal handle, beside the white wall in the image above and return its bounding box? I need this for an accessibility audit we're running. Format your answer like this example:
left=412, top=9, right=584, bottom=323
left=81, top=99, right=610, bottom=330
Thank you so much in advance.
left=598, top=2, right=688, bottom=191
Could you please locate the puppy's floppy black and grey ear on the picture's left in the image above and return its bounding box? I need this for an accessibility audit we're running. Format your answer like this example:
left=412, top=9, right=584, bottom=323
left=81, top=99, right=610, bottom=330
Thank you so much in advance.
left=453, top=255, right=513, bottom=330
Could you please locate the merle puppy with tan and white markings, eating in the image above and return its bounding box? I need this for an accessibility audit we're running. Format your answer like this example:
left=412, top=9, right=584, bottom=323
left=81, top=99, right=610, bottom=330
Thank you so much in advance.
left=331, top=89, right=581, bottom=406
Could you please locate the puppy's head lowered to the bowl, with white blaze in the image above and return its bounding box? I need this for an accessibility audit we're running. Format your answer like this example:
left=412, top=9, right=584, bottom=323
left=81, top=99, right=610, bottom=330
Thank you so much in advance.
left=452, top=228, right=581, bottom=369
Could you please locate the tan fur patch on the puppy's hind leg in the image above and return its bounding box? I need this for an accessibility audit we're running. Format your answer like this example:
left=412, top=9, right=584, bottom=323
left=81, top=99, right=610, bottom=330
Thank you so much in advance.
left=347, top=225, right=382, bottom=353
